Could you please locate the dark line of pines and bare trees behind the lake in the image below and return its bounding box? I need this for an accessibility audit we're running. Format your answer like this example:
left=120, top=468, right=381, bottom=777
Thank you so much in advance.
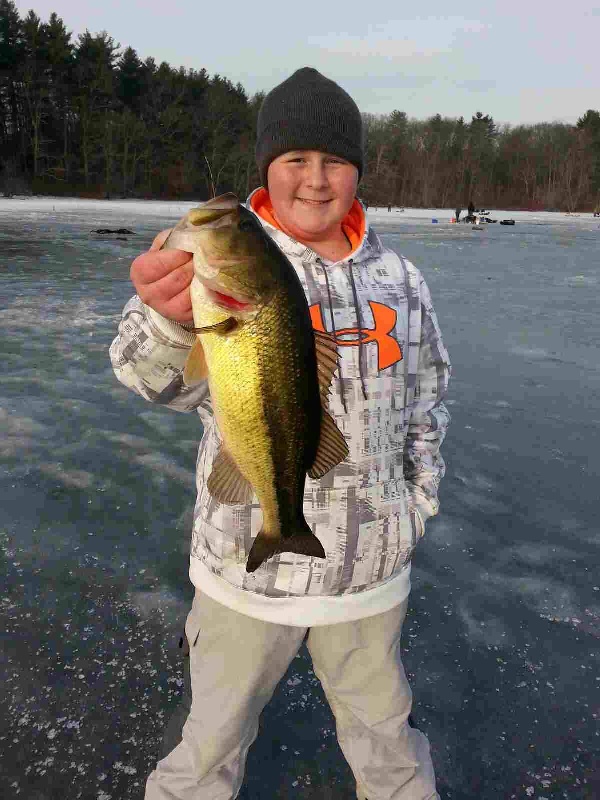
left=0, top=0, right=600, bottom=211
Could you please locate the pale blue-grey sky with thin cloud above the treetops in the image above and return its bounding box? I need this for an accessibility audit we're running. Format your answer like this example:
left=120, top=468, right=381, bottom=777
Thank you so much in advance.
left=16, top=0, right=600, bottom=126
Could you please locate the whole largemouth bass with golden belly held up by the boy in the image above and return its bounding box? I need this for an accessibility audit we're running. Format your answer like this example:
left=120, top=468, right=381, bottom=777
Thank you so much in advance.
left=163, top=194, right=348, bottom=572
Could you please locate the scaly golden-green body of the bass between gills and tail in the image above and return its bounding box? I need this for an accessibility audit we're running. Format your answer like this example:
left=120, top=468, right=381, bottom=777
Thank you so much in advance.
left=199, top=284, right=320, bottom=538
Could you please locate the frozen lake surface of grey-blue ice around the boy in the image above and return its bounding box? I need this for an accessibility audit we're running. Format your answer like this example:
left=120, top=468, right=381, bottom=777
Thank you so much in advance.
left=0, top=198, right=600, bottom=800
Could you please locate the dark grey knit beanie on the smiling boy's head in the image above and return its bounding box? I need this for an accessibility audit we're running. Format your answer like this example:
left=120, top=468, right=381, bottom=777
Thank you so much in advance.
left=255, top=67, right=364, bottom=187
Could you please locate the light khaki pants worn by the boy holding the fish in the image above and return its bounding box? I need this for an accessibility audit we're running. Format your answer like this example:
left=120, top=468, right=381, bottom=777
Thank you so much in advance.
left=145, top=592, right=439, bottom=800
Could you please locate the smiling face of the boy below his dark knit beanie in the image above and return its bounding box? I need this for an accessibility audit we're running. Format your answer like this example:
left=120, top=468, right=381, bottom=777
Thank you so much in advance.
left=267, top=150, right=358, bottom=242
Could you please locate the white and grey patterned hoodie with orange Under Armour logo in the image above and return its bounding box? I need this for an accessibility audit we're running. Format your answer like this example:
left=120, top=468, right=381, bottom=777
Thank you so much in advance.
left=110, top=193, right=451, bottom=627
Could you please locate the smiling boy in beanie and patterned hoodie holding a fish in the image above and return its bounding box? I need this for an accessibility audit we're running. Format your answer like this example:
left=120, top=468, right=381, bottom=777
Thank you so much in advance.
left=110, top=68, right=451, bottom=800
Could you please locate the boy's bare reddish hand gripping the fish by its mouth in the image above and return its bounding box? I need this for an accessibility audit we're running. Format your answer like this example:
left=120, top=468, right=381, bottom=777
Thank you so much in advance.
left=129, top=229, right=194, bottom=322
